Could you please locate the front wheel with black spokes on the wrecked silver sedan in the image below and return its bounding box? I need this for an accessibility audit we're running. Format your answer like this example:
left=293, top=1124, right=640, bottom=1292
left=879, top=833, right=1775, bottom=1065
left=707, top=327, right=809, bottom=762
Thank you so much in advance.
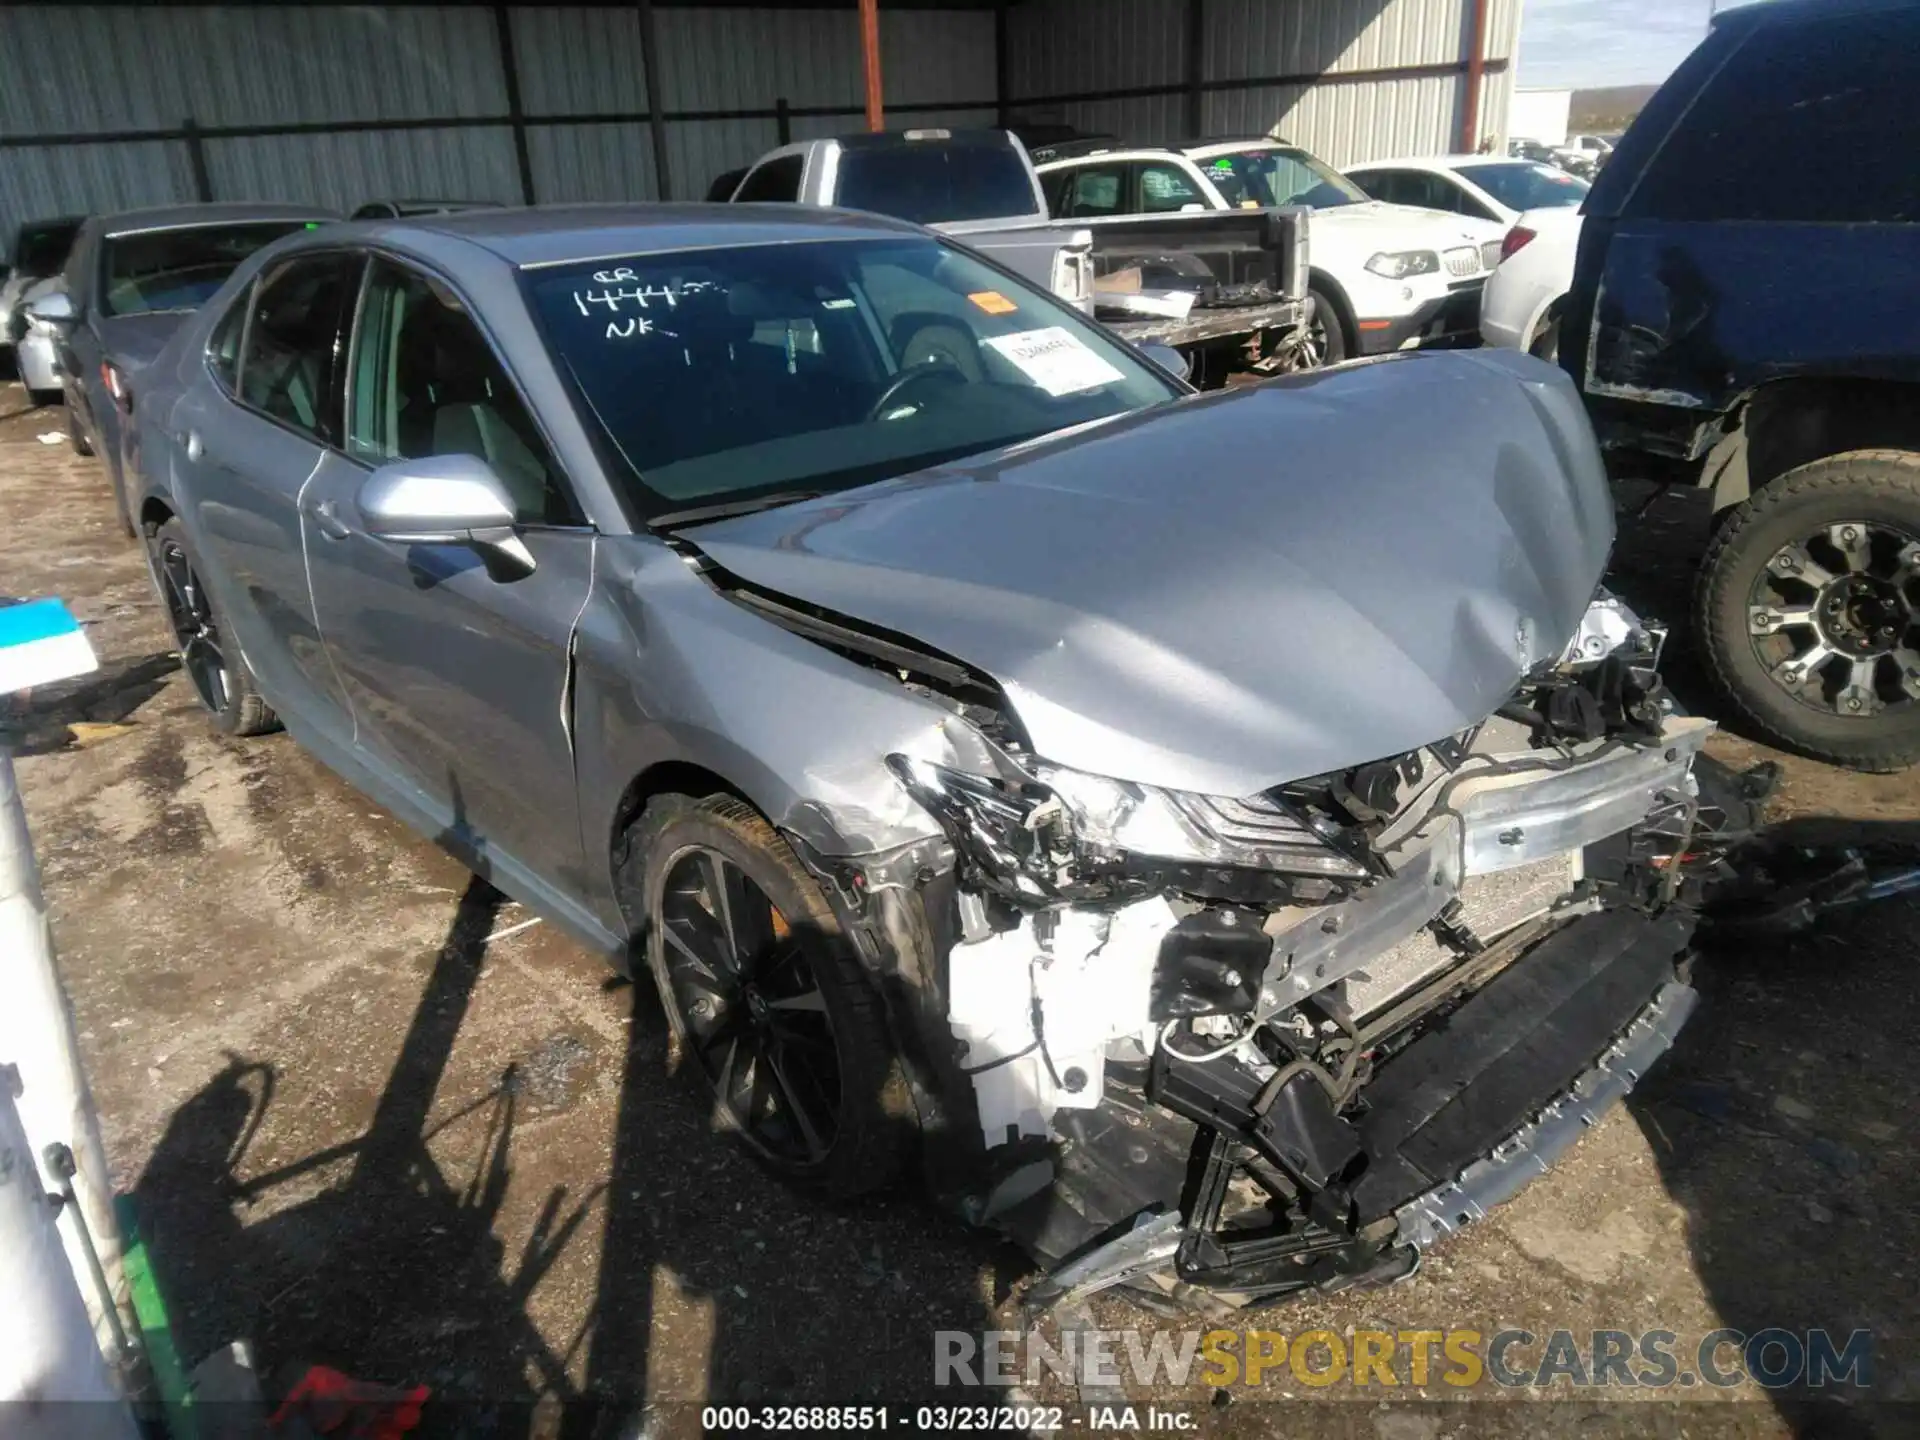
left=620, top=795, right=918, bottom=1198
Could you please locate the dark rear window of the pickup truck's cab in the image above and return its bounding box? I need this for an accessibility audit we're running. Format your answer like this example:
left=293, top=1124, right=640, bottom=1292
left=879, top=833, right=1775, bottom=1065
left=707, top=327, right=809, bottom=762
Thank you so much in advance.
left=833, top=136, right=1041, bottom=225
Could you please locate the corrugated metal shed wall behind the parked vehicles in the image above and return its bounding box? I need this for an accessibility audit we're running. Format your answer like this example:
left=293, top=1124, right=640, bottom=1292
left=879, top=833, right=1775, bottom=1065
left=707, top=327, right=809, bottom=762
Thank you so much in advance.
left=0, top=0, right=1521, bottom=232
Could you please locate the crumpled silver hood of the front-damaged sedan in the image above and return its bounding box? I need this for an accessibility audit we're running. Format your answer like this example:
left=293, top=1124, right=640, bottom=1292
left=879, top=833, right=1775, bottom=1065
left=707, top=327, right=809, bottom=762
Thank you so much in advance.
left=685, top=351, right=1613, bottom=795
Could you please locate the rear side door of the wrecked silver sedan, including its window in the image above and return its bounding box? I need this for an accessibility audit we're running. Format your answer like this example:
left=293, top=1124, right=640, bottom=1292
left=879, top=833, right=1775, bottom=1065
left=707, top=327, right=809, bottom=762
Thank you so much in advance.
left=169, top=250, right=367, bottom=741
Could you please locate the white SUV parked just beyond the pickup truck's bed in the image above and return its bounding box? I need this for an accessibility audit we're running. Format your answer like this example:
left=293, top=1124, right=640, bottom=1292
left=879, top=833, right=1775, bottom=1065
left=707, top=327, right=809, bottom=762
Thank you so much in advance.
left=1039, top=140, right=1503, bottom=363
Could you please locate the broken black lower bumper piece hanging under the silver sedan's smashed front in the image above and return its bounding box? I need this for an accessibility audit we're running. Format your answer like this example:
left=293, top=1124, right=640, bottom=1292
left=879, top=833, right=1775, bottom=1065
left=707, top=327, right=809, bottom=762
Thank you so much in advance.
left=1027, top=912, right=1695, bottom=1311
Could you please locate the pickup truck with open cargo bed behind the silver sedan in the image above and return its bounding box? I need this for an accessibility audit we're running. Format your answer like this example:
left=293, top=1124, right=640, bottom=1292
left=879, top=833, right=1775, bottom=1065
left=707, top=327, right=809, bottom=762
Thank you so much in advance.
left=716, top=129, right=1308, bottom=378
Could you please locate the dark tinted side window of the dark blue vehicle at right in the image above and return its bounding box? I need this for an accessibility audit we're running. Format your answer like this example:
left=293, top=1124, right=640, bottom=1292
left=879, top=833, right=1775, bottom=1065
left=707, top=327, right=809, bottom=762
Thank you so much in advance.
left=1622, top=8, right=1920, bottom=225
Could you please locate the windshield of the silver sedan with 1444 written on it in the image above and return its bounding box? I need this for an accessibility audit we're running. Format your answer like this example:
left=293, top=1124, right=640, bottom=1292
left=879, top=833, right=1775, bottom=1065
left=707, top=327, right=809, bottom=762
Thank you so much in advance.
left=526, top=229, right=1179, bottom=518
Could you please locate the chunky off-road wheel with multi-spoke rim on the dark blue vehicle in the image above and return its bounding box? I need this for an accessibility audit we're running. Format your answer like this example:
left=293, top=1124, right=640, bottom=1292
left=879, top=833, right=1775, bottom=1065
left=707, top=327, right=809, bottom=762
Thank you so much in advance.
left=1695, top=449, right=1920, bottom=772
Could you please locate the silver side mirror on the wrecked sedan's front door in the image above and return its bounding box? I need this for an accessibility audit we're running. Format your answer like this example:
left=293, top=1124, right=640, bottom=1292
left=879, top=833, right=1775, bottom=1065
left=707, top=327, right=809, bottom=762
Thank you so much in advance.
left=353, top=455, right=534, bottom=580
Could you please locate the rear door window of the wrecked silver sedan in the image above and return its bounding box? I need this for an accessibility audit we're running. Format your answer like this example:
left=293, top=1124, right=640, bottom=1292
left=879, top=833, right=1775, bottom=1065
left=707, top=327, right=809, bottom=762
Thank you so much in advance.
left=240, top=250, right=365, bottom=445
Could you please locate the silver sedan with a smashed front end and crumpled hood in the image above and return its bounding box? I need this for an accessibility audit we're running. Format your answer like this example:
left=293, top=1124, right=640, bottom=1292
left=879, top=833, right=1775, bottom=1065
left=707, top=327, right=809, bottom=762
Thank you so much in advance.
left=120, top=205, right=1711, bottom=1300
